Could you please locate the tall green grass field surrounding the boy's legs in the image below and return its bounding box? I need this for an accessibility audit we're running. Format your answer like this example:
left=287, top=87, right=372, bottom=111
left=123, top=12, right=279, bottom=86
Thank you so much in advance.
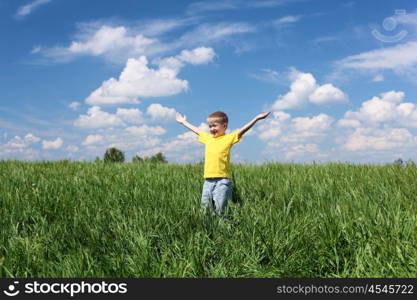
left=0, top=161, right=417, bottom=278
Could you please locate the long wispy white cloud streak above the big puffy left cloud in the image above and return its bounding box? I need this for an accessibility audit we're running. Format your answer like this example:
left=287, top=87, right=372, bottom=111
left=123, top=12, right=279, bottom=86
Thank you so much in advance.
left=32, top=18, right=247, bottom=64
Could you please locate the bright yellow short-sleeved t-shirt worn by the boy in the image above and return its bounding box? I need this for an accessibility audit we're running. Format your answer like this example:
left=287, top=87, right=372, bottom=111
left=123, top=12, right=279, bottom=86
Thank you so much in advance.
left=198, top=131, right=242, bottom=178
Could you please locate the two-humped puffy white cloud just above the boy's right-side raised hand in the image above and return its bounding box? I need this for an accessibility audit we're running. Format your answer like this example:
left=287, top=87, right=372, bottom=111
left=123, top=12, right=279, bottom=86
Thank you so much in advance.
left=272, top=70, right=348, bottom=110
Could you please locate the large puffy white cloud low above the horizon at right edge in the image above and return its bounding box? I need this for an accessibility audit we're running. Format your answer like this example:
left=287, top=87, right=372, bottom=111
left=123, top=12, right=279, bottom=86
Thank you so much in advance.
left=335, top=91, right=417, bottom=159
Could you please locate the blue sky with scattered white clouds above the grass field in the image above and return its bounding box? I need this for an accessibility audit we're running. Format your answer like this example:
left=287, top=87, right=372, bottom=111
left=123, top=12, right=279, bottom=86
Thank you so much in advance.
left=0, top=0, right=417, bottom=163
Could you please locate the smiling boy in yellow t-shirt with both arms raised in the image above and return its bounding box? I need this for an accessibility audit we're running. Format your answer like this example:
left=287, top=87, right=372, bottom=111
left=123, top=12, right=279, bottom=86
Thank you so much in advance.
left=176, top=111, right=270, bottom=215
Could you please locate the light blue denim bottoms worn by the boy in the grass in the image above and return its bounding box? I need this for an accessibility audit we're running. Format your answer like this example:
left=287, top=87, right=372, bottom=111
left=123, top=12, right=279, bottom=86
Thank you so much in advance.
left=201, top=178, right=232, bottom=215
